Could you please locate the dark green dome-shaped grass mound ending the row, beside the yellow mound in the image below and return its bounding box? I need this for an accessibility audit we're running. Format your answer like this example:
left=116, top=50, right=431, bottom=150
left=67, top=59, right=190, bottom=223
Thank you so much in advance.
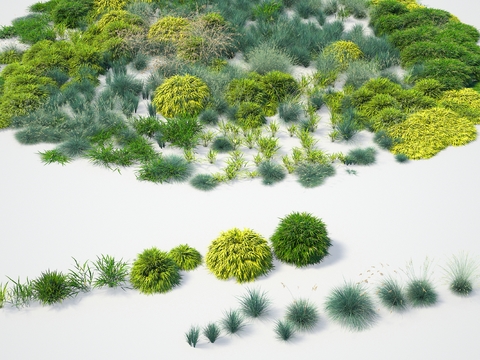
left=270, top=212, right=331, bottom=267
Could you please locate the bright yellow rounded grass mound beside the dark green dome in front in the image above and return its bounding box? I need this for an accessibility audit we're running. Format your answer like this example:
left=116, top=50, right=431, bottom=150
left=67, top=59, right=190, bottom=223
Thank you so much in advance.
left=205, top=228, right=273, bottom=283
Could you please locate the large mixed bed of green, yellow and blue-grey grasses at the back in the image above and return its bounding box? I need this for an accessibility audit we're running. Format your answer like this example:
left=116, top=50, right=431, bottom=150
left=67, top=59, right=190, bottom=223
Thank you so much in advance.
left=0, top=0, right=480, bottom=190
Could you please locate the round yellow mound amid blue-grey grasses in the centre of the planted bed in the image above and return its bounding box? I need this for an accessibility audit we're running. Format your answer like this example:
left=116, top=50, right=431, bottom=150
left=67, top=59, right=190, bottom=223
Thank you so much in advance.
left=152, top=75, right=210, bottom=117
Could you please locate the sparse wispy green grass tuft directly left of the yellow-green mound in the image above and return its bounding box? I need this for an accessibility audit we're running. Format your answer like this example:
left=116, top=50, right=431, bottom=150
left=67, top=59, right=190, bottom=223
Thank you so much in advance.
left=93, top=255, right=128, bottom=289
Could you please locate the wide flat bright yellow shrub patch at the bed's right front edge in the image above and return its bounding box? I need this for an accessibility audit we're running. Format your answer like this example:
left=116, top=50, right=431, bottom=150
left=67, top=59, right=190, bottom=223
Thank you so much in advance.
left=388, top=107, right=477, bottom=159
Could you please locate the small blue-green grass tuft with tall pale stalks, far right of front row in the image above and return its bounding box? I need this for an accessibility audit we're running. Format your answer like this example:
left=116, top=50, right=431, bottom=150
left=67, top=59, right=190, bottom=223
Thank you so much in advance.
left=443, top=253, right=479, bottom=296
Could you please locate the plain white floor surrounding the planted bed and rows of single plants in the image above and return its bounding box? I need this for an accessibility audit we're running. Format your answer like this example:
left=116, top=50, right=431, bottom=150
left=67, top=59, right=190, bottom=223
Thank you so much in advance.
left=0, top=0, right=480, bottom=360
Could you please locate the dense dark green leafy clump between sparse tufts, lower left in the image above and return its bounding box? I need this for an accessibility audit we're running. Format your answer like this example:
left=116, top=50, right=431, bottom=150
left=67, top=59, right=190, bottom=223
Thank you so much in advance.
left=32, top=270, right=75, bottom=305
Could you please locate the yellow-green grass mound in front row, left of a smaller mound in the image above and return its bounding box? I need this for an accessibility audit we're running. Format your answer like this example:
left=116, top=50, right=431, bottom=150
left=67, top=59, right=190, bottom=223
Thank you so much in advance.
left=130, top=247, right=182, bottom=294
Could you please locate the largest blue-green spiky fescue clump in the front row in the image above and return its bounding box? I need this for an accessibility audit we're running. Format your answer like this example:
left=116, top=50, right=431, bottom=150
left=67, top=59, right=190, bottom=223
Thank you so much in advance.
left=325, top=283, right=377, bottom=331
